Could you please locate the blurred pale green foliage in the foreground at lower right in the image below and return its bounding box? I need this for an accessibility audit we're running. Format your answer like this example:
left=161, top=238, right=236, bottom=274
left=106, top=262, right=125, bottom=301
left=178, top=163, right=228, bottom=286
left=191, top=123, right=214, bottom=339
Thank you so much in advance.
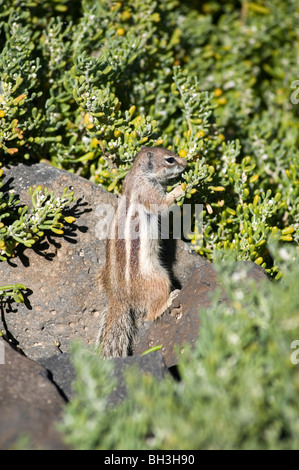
left=62, top=245, right=299, bottom=450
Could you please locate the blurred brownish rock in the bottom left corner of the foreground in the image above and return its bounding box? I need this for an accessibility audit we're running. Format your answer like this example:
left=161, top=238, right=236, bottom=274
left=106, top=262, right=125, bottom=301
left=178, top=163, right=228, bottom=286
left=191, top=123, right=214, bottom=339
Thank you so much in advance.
left=0, top=338, right=66, bottom=450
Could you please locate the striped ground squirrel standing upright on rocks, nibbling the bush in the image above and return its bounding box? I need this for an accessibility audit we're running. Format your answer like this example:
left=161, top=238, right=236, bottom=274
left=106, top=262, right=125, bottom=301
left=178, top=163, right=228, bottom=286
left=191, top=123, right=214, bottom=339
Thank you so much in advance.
left=98, top=147, right=187, bottom=358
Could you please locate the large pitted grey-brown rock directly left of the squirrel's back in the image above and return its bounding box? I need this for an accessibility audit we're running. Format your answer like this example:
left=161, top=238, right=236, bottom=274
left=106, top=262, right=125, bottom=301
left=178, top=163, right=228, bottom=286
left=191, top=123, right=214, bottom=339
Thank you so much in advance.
left=0, top=164, right=115, bottom=359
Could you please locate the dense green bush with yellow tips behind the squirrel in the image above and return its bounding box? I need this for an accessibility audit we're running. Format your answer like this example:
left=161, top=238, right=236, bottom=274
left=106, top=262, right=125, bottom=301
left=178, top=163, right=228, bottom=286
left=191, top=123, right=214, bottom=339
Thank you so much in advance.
left=0, top=0, right=299, bottom=278
